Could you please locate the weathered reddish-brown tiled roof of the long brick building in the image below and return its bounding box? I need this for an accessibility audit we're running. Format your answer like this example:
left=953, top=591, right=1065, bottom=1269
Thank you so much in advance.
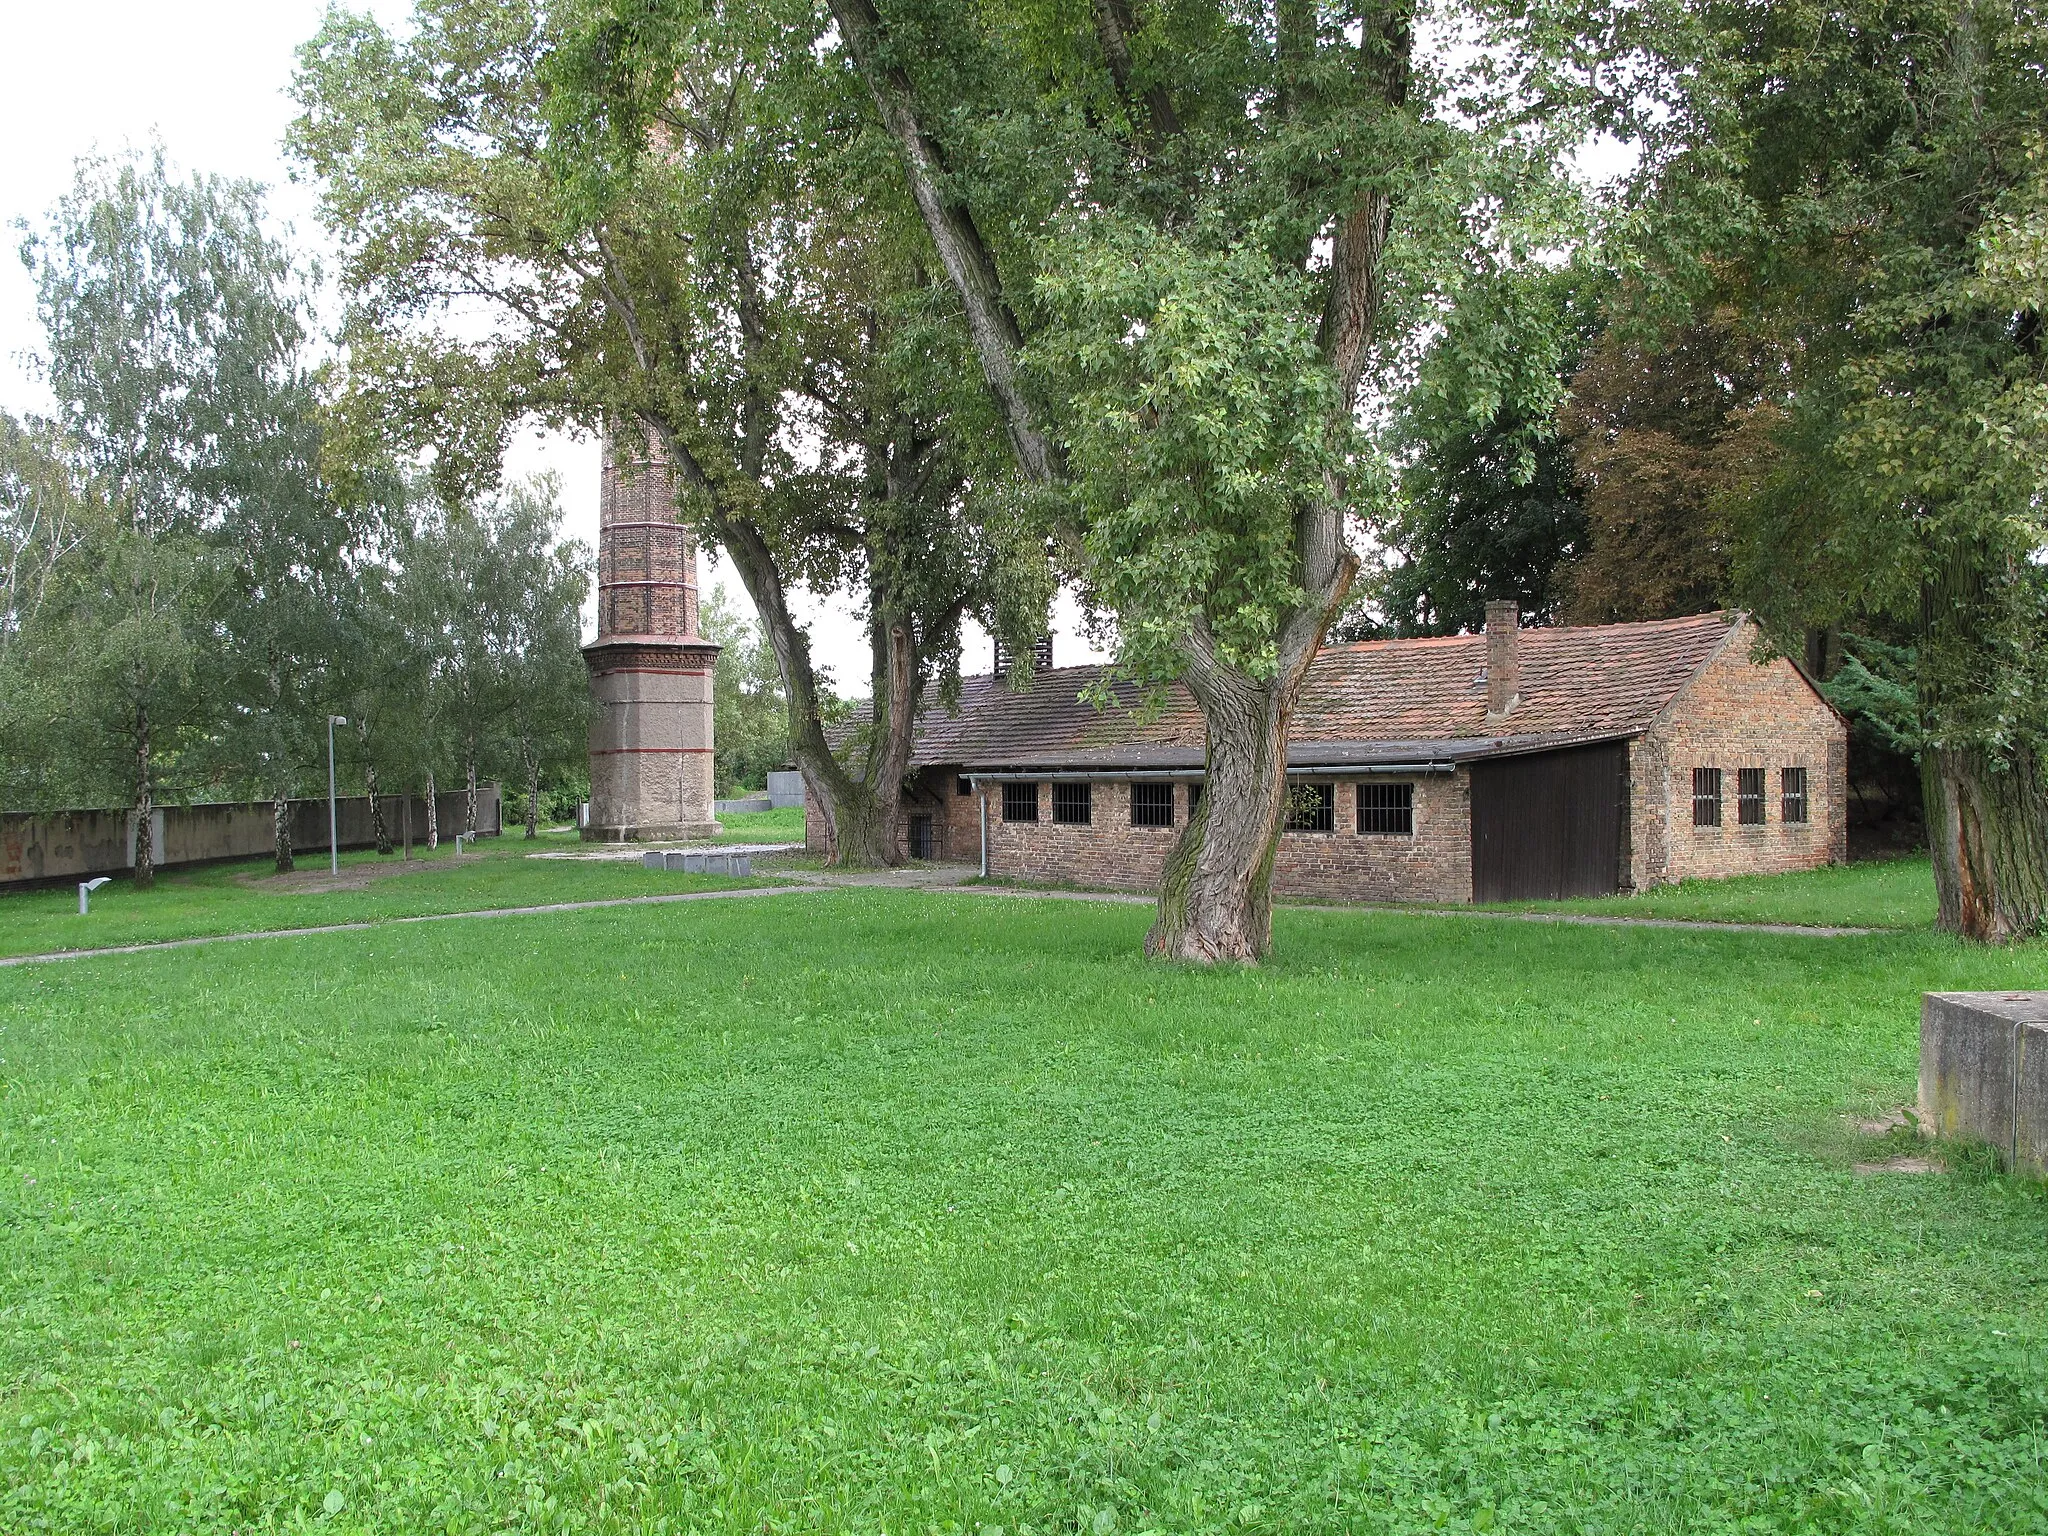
left=911, top=612, right=1741, bottom=772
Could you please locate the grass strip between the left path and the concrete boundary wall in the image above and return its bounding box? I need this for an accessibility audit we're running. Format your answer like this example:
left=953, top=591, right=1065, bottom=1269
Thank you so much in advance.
left=0, top=831, right=756, bottom=956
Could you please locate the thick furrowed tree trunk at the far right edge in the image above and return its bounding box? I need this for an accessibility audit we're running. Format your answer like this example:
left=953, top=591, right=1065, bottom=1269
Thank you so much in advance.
left=1921, top=748, right=2048, bottom=944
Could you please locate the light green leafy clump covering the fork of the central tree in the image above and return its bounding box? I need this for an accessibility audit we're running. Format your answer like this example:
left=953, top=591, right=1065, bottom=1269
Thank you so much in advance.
left=1026, top=219, right=1356, bottom=678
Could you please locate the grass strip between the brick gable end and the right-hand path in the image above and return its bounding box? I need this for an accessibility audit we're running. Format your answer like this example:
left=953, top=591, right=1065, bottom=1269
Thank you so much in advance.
left=1511, top=854, right=1935, bottom=928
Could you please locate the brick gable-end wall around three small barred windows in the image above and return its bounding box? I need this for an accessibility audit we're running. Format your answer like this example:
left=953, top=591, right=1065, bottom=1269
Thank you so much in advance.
left=1628, top=625, right=1849, bottom=889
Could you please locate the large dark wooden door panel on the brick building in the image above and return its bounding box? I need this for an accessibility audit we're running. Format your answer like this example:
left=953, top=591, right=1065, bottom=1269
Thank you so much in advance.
left=1473, top=741, right=1628, bottom=901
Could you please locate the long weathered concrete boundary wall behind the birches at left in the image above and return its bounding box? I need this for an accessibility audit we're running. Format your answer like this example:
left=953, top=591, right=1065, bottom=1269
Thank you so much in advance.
left=0, top=784, right=504, bottom=891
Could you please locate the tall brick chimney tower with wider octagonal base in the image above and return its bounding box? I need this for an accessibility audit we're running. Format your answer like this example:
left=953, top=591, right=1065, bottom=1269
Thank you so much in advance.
left=584, top=436, right=719, bottom=842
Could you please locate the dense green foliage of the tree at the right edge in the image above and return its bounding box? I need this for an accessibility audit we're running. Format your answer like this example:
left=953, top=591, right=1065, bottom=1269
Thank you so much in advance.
left=1667, top=0, right=2048, bottom=754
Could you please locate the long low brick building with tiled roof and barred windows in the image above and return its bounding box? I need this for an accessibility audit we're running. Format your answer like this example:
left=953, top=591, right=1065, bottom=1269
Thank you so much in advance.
left=809, top=604, right=1847, bottom=901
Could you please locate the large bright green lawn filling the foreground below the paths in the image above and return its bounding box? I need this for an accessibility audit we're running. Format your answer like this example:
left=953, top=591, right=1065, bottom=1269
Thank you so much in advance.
left=0, top=891, right=2048, bottom=1536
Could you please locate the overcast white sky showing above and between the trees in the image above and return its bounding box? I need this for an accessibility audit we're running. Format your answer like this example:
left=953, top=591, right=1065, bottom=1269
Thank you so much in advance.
left=0, top=0, right=1085, bottom=692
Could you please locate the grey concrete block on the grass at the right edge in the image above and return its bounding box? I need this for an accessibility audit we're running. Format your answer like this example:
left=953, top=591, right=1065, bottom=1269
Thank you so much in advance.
left=1919, top=991, right=2048, bottom=1178
